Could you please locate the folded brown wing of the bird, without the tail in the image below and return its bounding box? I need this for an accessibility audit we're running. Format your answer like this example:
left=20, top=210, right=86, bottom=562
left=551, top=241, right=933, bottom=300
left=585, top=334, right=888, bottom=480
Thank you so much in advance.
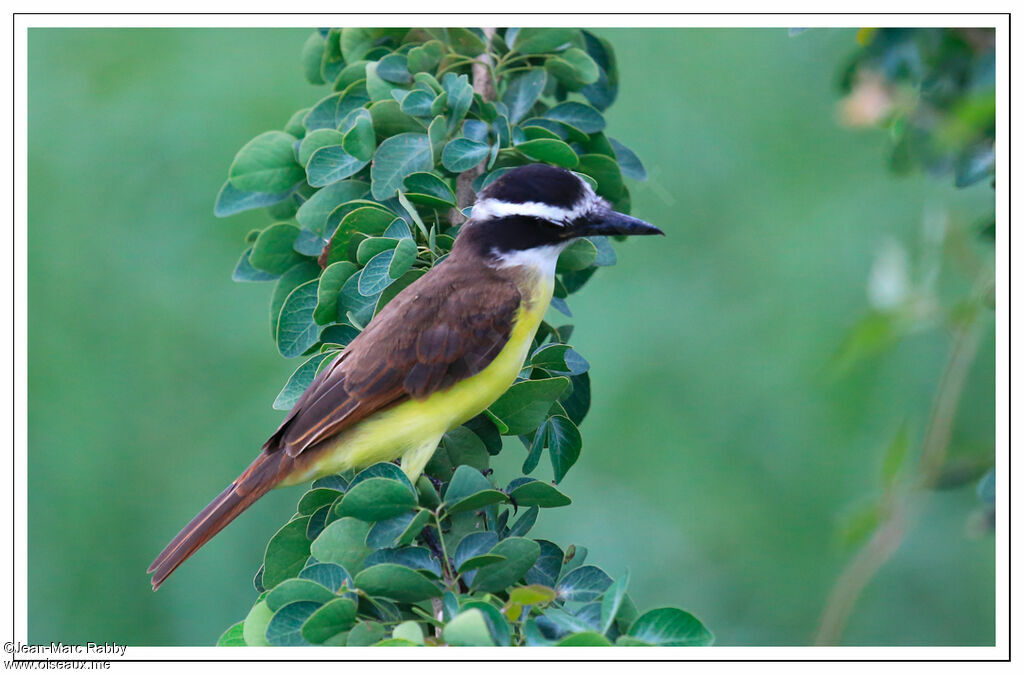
left=263, top=258, right=520, bottom=457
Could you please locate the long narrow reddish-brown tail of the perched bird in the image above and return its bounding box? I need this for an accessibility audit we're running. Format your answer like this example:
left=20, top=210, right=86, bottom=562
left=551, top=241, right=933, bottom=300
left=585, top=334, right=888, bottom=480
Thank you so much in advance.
left=146, top=452, right=287, bottom=590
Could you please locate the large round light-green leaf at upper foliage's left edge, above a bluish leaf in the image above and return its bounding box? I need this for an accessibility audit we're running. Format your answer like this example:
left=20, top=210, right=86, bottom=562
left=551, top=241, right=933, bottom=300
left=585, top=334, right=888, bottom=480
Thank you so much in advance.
left=227, top=131, right=303, bottom=193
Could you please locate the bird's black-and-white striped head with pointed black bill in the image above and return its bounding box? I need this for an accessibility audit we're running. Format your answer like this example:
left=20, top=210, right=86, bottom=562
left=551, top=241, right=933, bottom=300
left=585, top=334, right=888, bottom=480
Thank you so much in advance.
left=459, top=164, right=665, bottom=273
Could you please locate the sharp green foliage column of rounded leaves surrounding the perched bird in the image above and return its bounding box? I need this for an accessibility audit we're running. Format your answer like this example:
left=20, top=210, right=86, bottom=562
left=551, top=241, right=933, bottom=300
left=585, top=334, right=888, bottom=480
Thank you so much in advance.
left=209, top=28, right=712, bottom=646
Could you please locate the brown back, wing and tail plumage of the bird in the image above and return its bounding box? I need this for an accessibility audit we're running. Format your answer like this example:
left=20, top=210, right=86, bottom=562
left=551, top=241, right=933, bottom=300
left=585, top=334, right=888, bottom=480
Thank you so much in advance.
left=148, top=241, right=520, bottom=590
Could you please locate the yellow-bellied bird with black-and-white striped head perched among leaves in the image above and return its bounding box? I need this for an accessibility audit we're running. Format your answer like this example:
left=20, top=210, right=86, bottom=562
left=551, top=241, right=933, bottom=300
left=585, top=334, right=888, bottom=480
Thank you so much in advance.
left=147, top=164, right=665, bottom=590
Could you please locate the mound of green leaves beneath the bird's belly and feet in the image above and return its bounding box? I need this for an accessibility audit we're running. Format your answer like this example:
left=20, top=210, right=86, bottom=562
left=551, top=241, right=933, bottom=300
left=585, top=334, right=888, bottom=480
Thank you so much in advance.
left=218, top=462, right=713, bottom=646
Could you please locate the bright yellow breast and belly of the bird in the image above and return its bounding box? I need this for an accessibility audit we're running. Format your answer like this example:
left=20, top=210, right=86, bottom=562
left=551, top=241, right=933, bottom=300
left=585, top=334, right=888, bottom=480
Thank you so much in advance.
left=282, top=273, right=554, bottom=484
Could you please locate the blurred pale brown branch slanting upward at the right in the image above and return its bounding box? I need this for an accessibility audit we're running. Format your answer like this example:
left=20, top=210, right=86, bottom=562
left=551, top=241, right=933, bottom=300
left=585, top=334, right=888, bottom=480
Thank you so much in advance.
left=814, top=320, right=981, bottom=645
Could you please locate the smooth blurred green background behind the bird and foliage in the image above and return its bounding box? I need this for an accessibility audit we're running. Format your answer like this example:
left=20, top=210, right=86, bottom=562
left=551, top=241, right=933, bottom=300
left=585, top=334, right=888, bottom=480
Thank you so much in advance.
left=29, top=29, right=994, bottom=645
